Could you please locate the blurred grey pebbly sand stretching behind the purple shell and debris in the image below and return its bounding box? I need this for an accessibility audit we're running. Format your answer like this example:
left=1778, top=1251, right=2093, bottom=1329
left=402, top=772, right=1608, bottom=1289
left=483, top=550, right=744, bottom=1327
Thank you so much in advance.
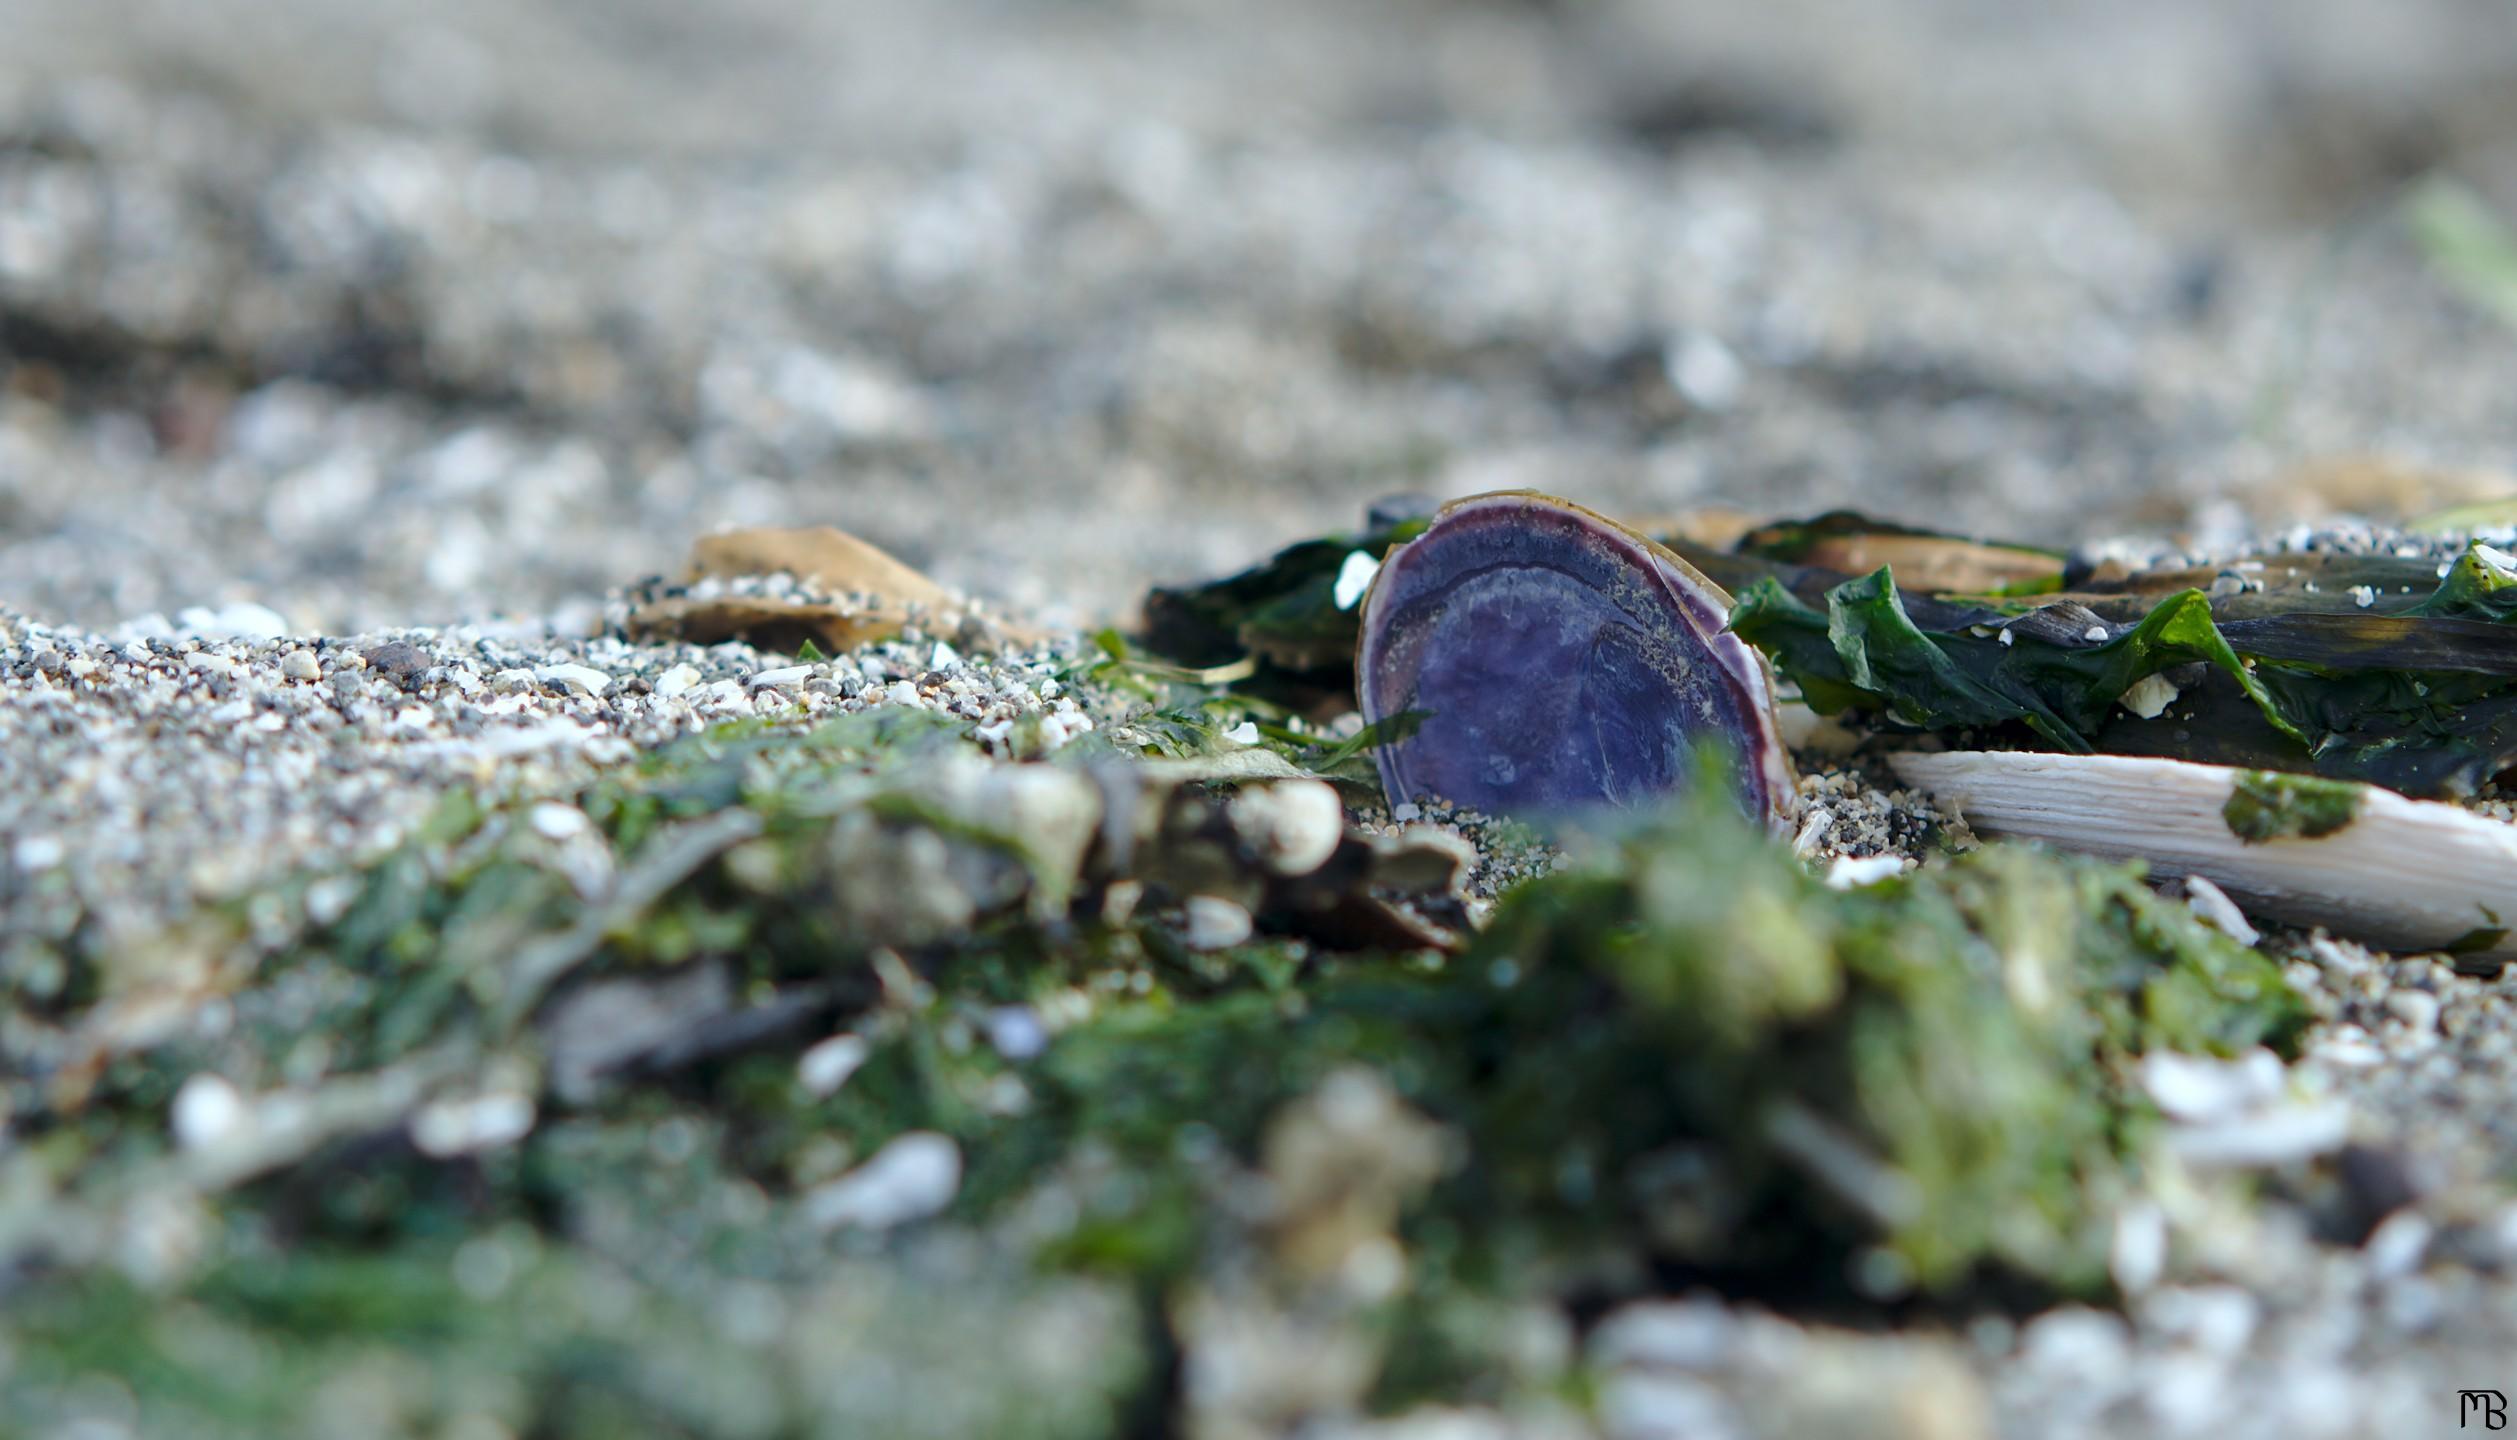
left=0, top=0, right=2517, bottom=629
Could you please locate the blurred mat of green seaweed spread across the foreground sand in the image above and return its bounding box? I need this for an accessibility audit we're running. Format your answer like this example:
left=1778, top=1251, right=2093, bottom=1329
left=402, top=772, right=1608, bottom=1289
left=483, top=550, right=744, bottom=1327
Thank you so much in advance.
left=0, top=715, right=2306, bottom=1440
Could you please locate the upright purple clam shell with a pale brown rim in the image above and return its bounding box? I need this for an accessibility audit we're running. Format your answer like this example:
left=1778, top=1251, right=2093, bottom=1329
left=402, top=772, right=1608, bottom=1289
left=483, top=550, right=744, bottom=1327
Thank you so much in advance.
left=1354, top=493, right=1795, bottom=828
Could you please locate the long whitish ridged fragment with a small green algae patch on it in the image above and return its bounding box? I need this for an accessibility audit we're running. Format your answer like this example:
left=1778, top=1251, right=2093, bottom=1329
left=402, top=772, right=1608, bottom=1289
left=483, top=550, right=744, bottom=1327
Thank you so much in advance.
left=1890, top=750, right=2517, bottom=959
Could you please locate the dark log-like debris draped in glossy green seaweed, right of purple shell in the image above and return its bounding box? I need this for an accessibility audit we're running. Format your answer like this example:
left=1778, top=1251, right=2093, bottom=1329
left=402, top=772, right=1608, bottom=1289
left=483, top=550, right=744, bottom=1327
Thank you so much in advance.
left=1732, top=533, right=2517, bottom=796
